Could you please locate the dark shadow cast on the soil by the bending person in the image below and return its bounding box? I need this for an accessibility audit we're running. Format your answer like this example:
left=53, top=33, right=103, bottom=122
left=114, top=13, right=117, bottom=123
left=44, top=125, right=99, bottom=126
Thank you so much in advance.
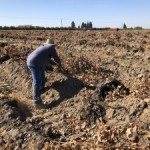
left=43, top=76, right=96, bottom=108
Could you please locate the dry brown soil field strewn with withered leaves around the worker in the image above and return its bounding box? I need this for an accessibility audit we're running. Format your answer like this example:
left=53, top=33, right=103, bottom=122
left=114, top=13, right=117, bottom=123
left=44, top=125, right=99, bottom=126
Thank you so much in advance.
left=0, top=30, right=150, bottom=150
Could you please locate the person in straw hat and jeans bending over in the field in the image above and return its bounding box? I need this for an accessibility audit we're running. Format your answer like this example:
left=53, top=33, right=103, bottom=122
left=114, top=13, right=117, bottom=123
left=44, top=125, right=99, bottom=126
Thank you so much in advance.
left=27, top=39, right=61, bottom=106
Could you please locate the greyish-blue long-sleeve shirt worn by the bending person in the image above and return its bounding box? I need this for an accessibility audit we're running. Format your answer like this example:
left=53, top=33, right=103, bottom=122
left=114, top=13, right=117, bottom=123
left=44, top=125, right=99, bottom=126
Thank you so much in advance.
left=27, top=45, right=61, bottom=69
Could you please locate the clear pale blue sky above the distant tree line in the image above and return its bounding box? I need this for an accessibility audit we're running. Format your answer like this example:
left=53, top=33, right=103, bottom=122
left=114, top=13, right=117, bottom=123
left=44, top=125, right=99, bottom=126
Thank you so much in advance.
left=0, top=0, right=150, bottom=28
